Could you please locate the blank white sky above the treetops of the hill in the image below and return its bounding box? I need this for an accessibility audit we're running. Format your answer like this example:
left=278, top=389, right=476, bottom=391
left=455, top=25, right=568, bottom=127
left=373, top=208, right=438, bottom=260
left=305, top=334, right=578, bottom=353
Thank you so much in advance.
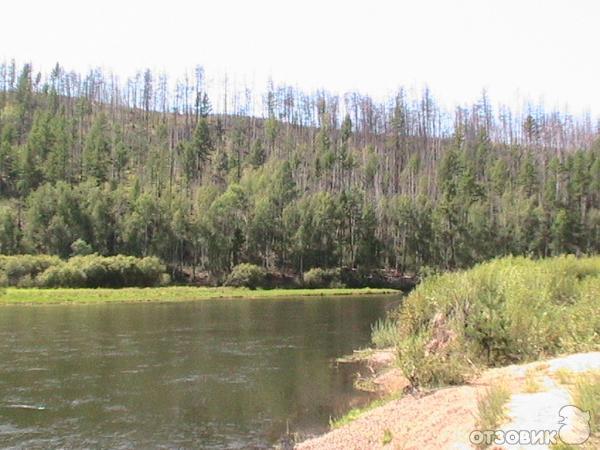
left=0, top=0, right=600, bottom=115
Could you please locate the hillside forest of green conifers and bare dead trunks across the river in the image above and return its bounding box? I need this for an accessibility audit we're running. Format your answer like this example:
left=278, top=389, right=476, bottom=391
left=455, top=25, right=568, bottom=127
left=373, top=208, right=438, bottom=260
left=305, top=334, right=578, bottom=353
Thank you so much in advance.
left=0, top=63, right=600, bottom=273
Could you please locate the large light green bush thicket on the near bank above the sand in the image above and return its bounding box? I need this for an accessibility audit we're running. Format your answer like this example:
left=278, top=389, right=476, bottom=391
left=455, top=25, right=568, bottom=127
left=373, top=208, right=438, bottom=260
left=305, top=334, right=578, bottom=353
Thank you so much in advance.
left=397, top=256, right=600, bottom=385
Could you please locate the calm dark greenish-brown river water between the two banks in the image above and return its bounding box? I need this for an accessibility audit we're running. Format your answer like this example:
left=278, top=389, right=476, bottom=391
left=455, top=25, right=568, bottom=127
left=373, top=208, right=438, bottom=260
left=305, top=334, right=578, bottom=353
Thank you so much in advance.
left=0, top=297, right=397, bottom=448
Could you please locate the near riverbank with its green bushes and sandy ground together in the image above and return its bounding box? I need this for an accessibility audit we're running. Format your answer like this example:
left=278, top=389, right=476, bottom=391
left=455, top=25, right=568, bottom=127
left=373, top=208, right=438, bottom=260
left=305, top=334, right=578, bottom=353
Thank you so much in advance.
left=299, top=256, right=600, bottom=450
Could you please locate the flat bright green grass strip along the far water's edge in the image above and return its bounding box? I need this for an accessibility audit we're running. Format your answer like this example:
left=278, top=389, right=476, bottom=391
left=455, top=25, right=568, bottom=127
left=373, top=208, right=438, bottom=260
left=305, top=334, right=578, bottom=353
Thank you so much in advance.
left=0, top=286, right=400, bottom=305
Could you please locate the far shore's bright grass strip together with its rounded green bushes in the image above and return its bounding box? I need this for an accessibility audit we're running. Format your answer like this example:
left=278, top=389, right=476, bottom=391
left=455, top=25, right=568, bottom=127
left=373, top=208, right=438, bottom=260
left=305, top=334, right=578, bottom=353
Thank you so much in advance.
left=0, top=254, right=396, bottom=304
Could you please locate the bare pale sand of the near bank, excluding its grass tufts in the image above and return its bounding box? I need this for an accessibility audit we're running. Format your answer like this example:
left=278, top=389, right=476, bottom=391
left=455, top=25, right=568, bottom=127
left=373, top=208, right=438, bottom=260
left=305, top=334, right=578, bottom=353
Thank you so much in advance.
left=297, top=352, right=600, bottom=450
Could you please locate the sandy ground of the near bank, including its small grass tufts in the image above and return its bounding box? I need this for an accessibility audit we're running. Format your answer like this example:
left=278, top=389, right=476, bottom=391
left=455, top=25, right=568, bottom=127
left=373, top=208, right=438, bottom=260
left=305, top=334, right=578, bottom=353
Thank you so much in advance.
left=296, top=352, right=600, bottom=450
